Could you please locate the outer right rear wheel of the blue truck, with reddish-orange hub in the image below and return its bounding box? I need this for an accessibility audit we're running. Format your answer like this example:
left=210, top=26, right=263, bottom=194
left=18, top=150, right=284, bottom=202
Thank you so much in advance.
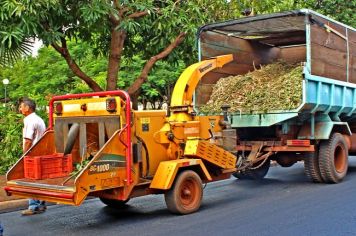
left=319, top=133, right=349, bottom=183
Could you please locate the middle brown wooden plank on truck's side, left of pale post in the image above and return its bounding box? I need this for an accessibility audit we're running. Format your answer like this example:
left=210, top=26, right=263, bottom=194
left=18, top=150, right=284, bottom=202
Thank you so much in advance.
left=311, top=43, right=347, bottom=67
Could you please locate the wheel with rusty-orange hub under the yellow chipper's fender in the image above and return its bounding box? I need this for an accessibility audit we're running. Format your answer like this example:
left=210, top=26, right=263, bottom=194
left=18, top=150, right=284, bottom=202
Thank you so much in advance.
left=164, top=170, right=203, bottom=215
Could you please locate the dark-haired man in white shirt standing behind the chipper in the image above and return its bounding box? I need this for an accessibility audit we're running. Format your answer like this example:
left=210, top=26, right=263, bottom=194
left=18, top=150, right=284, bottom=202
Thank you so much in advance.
left=19, top=98, right=46, bottom=216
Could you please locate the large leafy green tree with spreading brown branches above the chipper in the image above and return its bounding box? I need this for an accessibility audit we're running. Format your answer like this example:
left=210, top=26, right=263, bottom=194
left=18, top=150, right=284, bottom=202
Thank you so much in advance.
left=0, top=0, right=334, bottom=98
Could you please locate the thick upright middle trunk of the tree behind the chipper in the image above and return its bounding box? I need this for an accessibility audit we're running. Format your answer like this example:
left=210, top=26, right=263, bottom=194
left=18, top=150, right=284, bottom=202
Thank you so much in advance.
left=106, top=29, right=126, bottom=91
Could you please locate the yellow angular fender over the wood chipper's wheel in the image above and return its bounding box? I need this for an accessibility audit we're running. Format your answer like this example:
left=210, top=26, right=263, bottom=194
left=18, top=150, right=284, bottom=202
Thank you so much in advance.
left=150, top=159, right=212, bottom=190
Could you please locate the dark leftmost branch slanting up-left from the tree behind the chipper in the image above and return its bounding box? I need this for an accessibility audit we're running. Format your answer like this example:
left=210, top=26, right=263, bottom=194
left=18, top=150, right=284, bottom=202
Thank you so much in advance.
left=51, top=38, right=103, bottom=92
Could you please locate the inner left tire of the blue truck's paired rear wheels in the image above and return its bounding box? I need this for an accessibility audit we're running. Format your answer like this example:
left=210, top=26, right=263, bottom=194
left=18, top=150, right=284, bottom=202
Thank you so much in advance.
left=304, top=151, right=324, bottom=183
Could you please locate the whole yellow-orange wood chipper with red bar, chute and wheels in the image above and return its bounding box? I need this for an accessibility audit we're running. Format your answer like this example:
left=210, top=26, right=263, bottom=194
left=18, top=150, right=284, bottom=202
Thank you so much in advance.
left=5, top=55, right=237, bottom=214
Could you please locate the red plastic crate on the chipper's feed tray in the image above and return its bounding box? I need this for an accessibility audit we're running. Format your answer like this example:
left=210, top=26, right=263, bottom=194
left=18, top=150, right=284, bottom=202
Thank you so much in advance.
left=24, top=153, right=73, bottom=180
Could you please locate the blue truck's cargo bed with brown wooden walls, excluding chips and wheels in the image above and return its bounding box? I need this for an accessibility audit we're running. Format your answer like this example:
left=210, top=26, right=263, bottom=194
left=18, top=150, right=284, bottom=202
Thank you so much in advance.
left=195, top=9, right=356, bottom=138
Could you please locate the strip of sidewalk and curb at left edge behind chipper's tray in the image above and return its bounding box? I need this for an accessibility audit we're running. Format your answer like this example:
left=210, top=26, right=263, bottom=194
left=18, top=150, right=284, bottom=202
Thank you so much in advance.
left=0, top=175, right=28, bottom=213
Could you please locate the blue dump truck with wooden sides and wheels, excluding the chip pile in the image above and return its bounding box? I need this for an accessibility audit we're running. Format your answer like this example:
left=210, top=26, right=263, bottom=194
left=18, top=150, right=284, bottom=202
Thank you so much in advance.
left=195, top=9, right=356, bottom=183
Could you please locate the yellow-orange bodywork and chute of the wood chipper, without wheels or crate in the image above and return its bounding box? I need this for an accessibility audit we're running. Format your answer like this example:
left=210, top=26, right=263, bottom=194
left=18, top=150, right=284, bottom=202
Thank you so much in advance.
left=7, top=55, right=236, bottom=208
